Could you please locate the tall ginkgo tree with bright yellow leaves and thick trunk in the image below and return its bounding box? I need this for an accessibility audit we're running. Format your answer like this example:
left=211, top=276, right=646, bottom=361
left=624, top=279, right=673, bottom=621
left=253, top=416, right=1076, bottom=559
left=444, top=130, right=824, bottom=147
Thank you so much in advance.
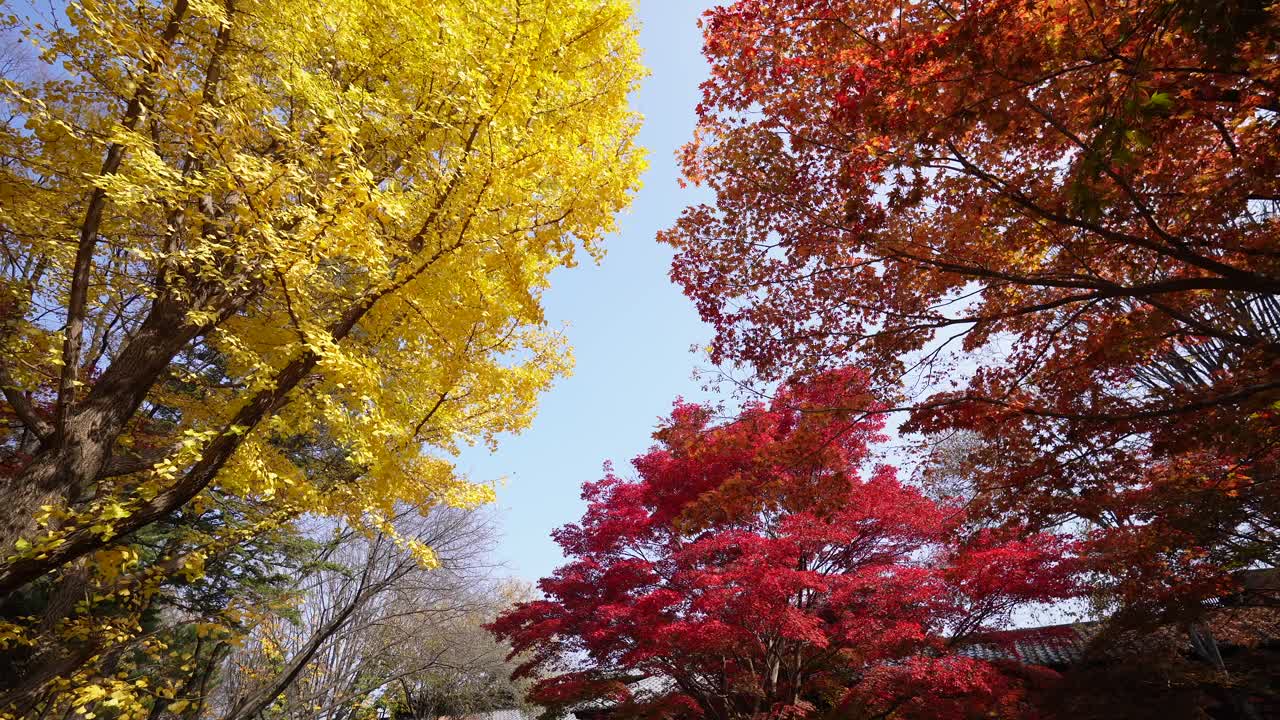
left=0, top=0, right=643, bottom=705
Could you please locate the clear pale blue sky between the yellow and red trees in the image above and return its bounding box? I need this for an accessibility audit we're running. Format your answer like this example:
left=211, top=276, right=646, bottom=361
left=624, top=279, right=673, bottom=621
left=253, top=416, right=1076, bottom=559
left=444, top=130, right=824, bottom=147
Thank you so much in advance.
left=458, top=0, right=713, bottom=580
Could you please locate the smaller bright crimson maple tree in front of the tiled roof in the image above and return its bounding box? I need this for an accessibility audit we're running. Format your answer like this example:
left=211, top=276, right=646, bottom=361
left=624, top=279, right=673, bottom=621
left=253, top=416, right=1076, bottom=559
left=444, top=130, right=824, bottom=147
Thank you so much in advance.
left=492, top=369, right=1075, bottom=720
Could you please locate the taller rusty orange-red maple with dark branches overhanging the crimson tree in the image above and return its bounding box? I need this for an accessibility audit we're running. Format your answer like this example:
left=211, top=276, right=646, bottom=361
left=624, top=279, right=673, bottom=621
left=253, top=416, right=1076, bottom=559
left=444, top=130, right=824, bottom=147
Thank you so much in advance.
left=663, top=0, right=1280, bottom=618
